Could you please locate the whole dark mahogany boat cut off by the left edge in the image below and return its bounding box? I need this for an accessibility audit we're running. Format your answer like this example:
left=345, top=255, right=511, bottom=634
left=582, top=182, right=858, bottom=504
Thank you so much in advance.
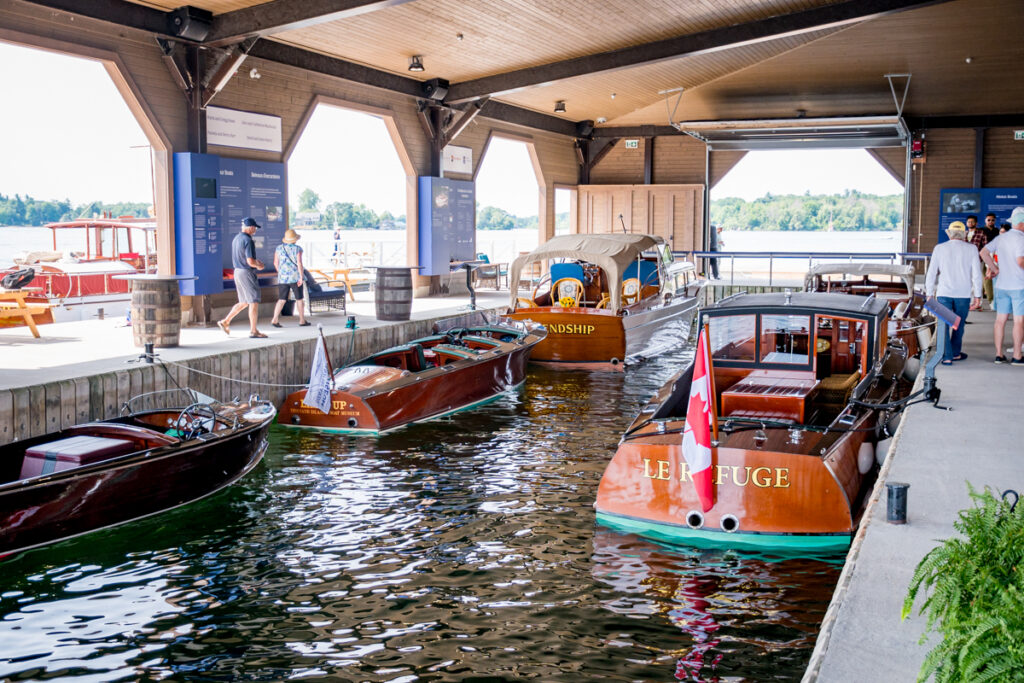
left=0, top=397, right=275, bottom=554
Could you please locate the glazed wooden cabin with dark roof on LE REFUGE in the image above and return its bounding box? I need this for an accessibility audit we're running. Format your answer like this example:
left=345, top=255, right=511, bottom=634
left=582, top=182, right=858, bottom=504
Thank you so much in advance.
left=699, top=293, right=889, bottom=424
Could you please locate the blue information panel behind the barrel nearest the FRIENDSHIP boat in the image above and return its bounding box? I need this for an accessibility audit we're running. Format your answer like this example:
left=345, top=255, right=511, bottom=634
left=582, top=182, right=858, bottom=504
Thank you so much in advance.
left=419, top=175, right=476, bottom=275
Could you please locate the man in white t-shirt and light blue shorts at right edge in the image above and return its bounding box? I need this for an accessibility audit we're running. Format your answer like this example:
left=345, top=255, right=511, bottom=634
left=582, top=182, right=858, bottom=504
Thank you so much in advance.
left=981, top=207, right=1024, bottom=367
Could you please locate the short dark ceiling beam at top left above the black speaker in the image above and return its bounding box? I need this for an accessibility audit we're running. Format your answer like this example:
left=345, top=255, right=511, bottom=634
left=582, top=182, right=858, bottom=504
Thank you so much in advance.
left=203, top=0, right=421, bottom=45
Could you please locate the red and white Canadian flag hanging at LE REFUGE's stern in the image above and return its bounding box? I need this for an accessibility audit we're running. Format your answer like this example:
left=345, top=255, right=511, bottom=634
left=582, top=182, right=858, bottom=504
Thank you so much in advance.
left=683, top=326, right=718, bottom=512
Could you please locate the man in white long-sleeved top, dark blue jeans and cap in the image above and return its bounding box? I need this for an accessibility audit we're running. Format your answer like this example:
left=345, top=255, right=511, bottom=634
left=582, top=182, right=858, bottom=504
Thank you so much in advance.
left=925, top=220, right=982, bottom=366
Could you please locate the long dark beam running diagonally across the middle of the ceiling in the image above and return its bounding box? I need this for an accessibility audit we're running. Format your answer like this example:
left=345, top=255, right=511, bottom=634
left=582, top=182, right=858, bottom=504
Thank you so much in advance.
left=445, top=0, right=951, bottom=103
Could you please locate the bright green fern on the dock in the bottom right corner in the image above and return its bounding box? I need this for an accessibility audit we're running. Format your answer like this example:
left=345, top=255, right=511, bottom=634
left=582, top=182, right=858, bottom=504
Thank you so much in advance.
left=902, top=484, right=1024, bottom=683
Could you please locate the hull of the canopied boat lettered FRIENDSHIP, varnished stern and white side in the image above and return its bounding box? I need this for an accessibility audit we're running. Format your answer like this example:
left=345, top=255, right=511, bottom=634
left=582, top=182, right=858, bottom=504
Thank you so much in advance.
left=508, top=297, right=697, bottom=371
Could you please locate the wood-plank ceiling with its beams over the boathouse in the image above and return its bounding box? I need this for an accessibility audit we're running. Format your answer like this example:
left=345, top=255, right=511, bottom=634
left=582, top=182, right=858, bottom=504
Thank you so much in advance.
left=27, top=0, right=1024, bottom=134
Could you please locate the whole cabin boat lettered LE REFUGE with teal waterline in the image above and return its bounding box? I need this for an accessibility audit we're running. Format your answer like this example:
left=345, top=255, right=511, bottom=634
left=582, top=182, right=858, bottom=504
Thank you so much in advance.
left=596, top=292, right=910, bottom=551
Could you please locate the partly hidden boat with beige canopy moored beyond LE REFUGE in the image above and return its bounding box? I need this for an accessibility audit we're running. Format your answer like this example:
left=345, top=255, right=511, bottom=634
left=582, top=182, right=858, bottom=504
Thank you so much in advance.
left=804, top=263, right=935, bottom=360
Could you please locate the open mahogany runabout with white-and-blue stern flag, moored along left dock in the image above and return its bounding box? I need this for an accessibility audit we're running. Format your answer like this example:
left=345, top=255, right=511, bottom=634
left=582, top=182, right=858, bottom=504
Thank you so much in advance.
left=278, top=323, right=547, bottom=434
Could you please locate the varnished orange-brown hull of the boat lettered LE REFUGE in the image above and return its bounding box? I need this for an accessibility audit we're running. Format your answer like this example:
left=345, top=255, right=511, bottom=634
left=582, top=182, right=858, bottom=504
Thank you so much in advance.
left=596, top=416, right=873, bottom=550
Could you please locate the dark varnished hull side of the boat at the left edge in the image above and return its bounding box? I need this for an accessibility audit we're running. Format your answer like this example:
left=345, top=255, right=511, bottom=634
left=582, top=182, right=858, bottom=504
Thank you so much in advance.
left=0, top=407, right=274, bottom=554
